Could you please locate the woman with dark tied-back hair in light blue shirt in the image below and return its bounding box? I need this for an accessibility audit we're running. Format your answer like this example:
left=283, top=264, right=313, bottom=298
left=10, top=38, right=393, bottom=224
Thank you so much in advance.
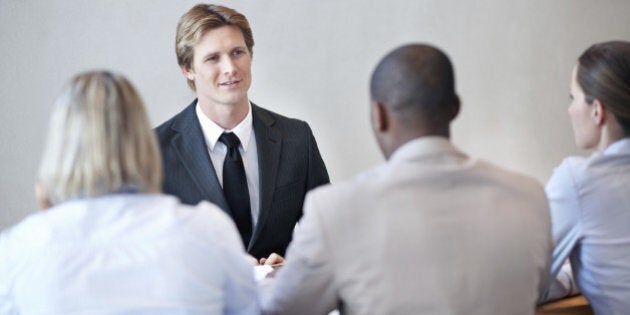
left=546, top=41, right=630, bottom=315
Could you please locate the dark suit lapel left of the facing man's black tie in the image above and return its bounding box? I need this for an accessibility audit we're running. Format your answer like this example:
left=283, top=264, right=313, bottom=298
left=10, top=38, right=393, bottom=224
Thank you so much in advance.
left=171, top=101, right=230, bottom=214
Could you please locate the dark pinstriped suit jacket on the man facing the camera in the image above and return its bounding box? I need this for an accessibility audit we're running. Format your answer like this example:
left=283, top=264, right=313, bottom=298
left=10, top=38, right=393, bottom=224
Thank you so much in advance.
left=156, top=100, right=329, bottom=258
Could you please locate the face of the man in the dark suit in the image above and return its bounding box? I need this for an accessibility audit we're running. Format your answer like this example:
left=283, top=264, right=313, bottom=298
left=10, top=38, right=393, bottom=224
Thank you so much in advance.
left=182, top=25, right=252, bottom=106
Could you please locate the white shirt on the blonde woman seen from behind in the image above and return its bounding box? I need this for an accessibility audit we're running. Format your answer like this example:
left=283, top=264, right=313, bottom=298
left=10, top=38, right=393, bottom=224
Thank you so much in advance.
left=0, top=194, right=259, bottom=315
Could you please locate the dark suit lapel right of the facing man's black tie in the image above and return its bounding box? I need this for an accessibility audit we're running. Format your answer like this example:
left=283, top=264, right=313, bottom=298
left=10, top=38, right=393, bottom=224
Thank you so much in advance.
left=249, top=103, right=282, bottom=248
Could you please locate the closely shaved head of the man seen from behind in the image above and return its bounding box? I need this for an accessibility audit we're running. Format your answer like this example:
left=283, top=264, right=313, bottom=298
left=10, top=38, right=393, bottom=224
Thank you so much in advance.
left=370, top=44, right=459, bottom=136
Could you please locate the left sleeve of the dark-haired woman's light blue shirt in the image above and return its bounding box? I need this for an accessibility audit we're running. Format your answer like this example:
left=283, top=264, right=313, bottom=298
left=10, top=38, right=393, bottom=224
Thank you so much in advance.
left=542, top=159, right=582, bottom=301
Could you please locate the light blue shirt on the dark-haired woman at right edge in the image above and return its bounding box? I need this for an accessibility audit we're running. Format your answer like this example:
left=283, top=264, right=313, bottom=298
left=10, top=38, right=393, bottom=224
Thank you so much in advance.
left=545, top=138, right=630, bottom=315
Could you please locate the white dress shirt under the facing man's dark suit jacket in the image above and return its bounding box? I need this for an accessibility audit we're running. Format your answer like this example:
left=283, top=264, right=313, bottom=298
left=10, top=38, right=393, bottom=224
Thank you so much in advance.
left=195, top=103, right=260, bottom=227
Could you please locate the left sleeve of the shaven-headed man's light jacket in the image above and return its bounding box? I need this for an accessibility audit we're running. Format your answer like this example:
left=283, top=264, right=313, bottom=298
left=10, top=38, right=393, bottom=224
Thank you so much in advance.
left=262, top=195, right=338, bottom=314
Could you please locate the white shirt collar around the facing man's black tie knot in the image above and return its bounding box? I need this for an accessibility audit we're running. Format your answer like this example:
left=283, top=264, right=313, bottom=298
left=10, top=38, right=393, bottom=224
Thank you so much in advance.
left=195, top=103, right=253, bottom=152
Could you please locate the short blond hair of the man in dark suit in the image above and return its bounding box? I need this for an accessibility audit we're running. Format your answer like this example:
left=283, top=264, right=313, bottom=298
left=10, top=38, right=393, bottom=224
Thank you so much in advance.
left=175, top=3, right=254, bottom=91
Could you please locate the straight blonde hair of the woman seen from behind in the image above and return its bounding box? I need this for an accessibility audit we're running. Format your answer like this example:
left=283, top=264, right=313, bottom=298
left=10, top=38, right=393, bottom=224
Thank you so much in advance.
left=38, top=71, right=162, bottom=205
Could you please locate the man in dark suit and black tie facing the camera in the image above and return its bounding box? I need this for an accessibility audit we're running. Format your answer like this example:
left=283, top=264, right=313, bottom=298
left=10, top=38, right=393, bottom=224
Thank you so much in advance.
left=156, top=4, right=329, bottom=258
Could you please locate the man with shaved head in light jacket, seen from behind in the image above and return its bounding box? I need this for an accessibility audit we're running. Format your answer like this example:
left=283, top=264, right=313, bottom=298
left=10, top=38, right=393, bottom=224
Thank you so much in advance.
left=263, top=44, right=551, bottom=315
